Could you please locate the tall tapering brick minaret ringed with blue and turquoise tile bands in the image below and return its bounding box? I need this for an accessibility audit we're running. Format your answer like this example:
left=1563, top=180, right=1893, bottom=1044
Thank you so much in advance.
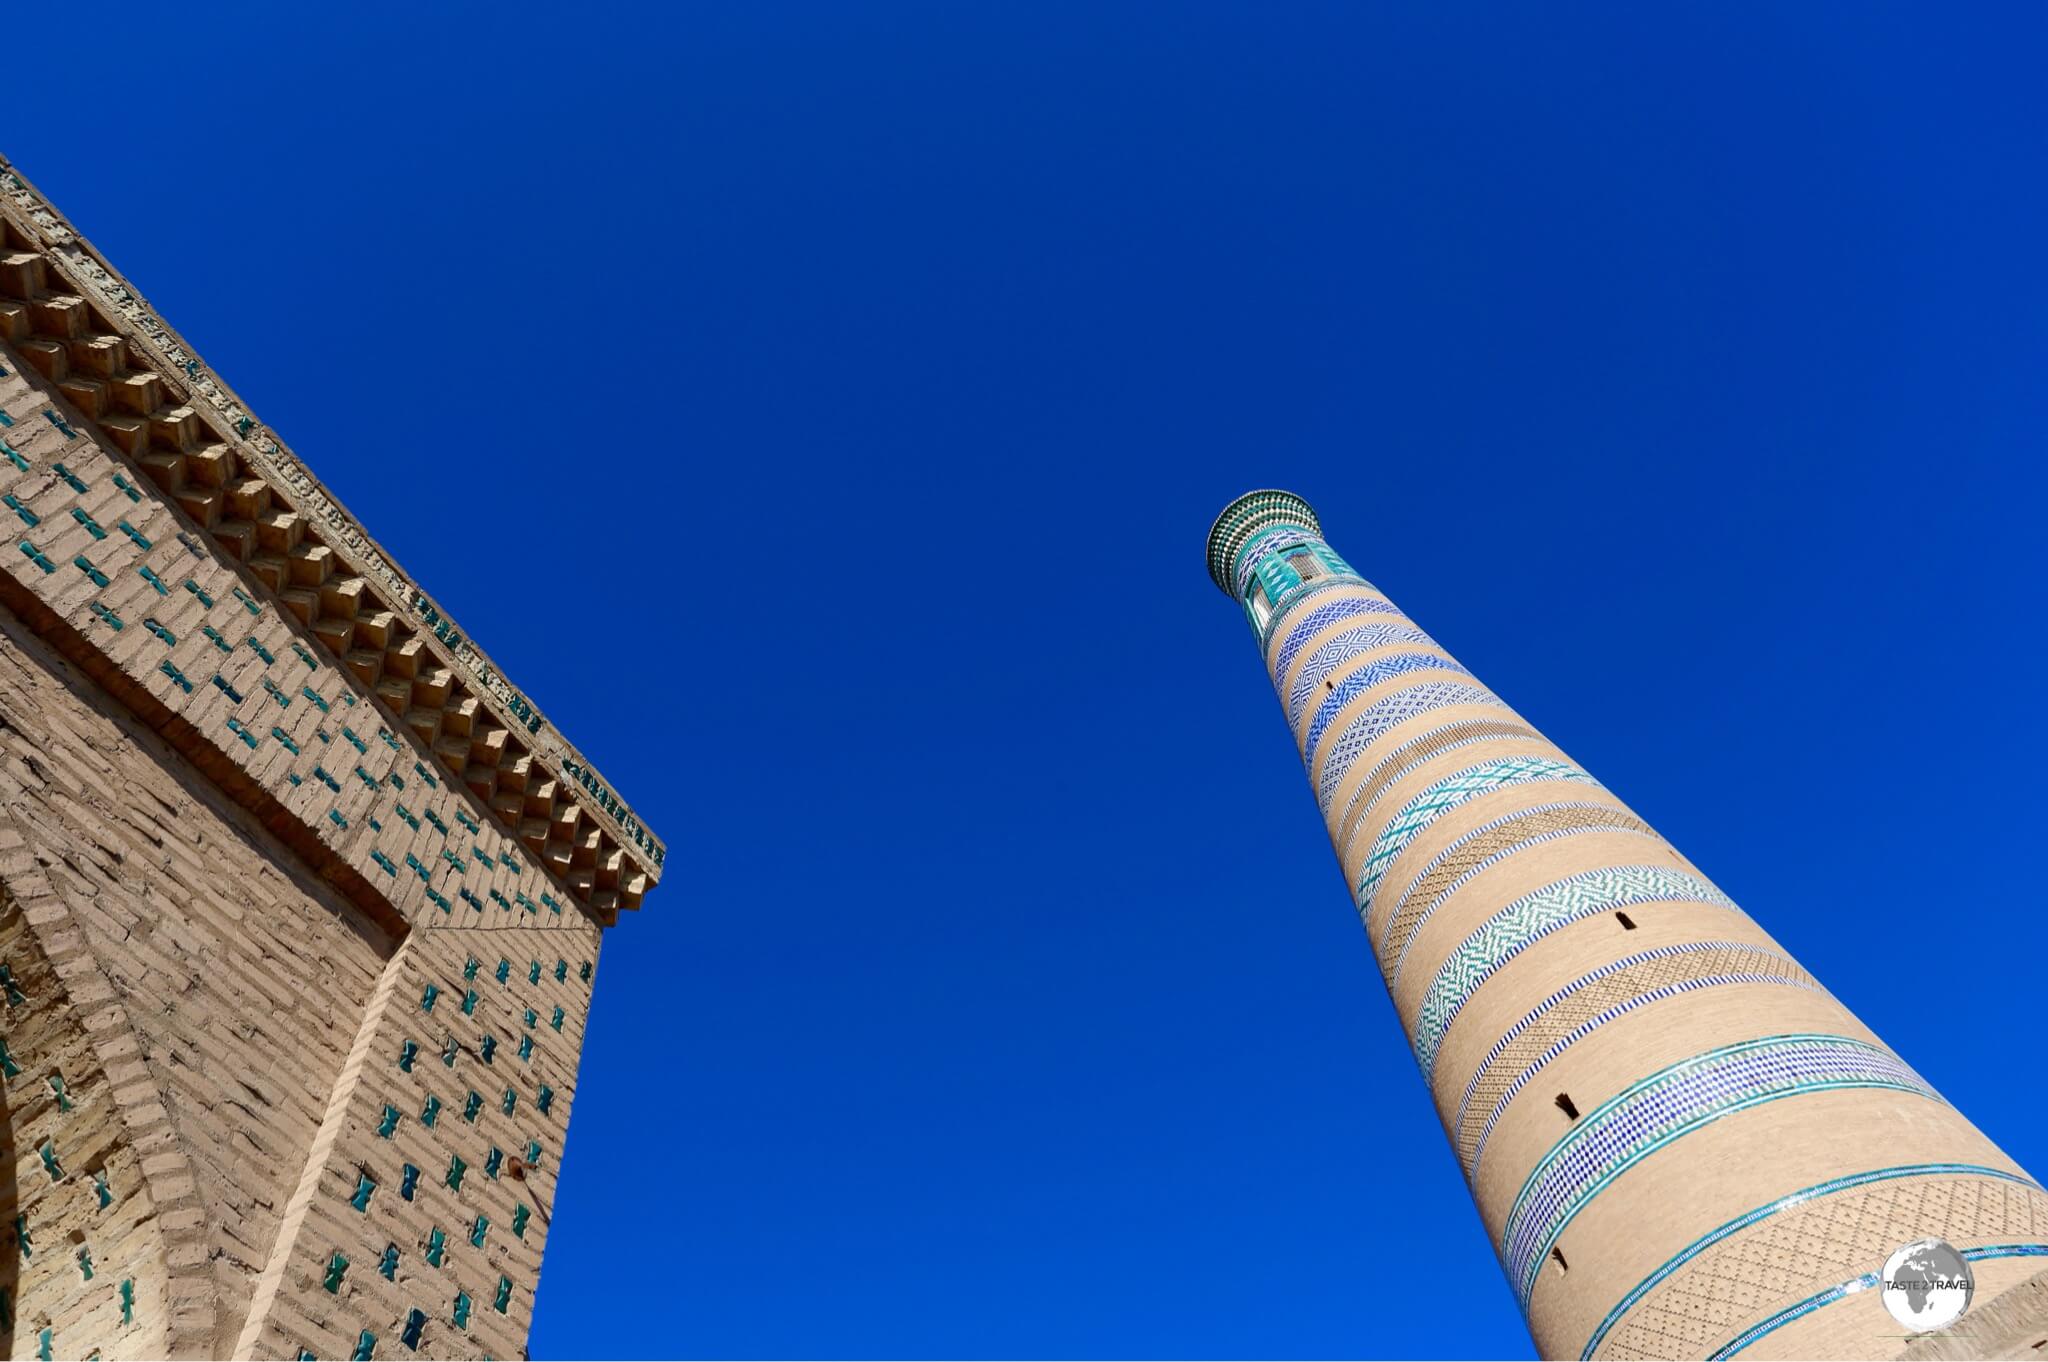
left=1208, top=492, right=2048, bottom=1358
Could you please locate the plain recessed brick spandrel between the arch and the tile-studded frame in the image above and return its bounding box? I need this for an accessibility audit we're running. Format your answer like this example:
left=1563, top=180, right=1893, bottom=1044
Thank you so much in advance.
left=0, top=614, right=391, bottom=1350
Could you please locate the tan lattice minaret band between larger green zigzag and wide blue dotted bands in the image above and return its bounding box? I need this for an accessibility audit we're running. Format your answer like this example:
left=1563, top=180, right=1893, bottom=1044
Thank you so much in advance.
left=1450, top=942, right=1821, bottom=1180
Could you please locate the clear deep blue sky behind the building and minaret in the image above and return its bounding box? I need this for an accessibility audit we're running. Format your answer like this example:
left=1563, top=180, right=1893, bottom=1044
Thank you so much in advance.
left=4, top=0, right=2048, bottom=1358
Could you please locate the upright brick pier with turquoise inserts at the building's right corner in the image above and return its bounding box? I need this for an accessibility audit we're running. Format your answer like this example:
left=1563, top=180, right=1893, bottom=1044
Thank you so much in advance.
left=238, top=928, right=596, bottom=1356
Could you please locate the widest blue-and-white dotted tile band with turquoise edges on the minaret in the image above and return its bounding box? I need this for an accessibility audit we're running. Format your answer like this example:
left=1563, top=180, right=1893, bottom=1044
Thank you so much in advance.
left=1501, top=1034, right=1942, bottom=1311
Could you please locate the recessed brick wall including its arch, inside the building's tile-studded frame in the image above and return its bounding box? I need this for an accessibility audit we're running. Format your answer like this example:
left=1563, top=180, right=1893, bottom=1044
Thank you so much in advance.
left=0, top=610, right=391, bottom=1356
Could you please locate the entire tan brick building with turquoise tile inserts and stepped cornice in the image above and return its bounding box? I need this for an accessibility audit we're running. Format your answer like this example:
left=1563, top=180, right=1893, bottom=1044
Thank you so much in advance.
left=0, top=162, right=666, bottom=1358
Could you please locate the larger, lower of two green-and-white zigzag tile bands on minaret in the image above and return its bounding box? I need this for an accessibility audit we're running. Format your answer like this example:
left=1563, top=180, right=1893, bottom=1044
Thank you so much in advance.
left=1415, top=866, right=1741, bottom=1077
